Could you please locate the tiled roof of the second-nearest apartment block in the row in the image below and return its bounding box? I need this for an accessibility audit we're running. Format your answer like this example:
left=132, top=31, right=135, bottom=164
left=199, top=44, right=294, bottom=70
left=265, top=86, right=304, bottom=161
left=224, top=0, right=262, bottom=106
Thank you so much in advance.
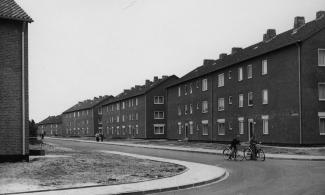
left=103, top=75, right=178, bottom=105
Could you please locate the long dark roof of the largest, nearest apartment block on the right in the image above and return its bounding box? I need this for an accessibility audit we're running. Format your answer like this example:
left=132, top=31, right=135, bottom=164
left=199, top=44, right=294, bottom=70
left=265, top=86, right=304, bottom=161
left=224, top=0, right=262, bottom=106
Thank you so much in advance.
left=169, top=15, right=325, bottom=87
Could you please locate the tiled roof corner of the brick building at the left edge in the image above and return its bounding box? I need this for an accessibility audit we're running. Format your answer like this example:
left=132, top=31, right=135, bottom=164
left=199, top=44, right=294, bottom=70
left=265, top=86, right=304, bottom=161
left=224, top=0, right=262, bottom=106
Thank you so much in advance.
left=0, top=0, right=33, bottom=22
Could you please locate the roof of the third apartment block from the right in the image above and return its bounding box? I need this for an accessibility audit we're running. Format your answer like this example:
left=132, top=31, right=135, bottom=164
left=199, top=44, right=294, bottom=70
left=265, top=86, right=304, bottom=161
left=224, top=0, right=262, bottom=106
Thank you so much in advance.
left=63, top=95, right=113, bottom=113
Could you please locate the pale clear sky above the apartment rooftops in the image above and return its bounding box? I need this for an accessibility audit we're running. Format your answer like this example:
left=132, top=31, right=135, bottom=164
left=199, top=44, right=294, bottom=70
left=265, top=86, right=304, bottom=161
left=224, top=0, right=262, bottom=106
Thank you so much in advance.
left=16, top=0, right=325, bottom=122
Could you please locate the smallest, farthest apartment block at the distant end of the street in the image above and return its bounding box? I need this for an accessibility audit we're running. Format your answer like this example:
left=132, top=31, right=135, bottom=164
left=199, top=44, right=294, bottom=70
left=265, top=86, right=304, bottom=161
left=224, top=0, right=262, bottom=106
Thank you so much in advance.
left=37, top=115, right=62, bottom=136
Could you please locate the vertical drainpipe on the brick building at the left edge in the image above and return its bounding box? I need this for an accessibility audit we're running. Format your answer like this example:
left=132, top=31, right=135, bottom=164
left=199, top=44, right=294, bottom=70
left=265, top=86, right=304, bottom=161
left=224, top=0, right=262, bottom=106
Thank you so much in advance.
left=21, top=22, right=26, bottom=155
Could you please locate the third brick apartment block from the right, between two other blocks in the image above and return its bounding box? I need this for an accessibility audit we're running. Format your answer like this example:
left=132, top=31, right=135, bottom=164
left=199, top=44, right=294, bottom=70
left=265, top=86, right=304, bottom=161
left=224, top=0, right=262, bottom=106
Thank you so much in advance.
left=62, top=95, right=113, bottom=136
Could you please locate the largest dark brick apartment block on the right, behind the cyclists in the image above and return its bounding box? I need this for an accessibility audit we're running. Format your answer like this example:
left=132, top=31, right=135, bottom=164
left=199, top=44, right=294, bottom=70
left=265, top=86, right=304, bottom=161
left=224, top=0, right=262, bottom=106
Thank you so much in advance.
left=167, top=11, right=325, bottom=144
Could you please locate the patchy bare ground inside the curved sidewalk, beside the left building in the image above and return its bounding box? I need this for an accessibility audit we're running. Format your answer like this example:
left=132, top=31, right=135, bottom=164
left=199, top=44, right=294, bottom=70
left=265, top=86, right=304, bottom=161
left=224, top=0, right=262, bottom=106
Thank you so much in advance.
left=0, top=145, right=186, bottom=193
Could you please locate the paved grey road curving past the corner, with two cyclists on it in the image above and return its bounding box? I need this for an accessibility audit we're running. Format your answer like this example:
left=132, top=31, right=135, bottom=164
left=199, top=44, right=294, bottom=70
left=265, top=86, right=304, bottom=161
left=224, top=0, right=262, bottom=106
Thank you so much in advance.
left=46, top=140, right=325, bottom=195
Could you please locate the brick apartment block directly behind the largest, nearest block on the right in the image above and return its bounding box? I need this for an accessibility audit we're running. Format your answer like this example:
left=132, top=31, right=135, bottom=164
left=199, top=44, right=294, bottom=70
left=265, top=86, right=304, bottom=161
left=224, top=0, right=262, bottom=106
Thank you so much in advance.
left=103, top=75, right=178, bottom=139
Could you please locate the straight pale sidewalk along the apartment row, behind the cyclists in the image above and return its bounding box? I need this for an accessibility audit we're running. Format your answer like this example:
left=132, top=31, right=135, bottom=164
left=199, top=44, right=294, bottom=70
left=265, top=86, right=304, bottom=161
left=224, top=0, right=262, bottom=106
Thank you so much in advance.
left=47, top=137, right=325, bottom=161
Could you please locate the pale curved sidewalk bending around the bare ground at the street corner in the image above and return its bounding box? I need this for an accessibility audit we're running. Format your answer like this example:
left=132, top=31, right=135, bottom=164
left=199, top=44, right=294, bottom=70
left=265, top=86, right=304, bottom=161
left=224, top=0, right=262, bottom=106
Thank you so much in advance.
left=18, top=150, right=228, bottom=195
